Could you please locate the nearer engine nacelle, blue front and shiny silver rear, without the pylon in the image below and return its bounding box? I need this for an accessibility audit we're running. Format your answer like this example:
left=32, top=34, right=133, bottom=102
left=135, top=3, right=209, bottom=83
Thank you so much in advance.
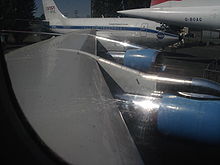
left=115, top=93, right=220, bottom=145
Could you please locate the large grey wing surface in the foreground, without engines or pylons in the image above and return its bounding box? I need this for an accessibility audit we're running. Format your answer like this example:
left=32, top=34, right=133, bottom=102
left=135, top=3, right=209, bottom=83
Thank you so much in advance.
left=5, top=30, right=143, bottom=165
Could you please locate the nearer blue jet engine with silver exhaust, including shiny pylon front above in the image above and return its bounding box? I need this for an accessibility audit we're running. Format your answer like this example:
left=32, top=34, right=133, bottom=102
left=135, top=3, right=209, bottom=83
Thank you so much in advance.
left=115, top=77, right=220, bottom=145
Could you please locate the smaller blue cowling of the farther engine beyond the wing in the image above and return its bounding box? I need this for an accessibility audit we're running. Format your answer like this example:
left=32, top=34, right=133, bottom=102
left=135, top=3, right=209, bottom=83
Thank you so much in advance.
left=124, top=49, right=159, bottom=72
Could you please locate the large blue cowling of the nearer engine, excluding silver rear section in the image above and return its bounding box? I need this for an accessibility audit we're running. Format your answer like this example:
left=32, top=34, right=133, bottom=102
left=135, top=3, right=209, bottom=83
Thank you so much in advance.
left=157, top=95, right=220, bottom=144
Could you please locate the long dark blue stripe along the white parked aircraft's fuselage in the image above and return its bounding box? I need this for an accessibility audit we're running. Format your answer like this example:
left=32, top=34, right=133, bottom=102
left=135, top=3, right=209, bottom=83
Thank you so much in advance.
left=49, top=25, right=178, bottom=37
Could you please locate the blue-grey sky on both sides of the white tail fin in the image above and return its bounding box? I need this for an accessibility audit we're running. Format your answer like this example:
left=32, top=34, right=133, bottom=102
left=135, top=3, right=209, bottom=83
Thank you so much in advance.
left=35, top=0, right=91, bottom=17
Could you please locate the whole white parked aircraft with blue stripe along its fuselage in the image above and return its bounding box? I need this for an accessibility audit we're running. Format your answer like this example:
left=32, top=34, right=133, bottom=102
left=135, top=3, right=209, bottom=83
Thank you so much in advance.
left=42, top=0, right=179, bottom=47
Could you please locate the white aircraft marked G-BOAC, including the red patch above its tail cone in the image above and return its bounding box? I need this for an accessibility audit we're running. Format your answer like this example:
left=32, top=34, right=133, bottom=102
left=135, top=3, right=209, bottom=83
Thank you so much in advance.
left=118, top=0, right=220, bottom=30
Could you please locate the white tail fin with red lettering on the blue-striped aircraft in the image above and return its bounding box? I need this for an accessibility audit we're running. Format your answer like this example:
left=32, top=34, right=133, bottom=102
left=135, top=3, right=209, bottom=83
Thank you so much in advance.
left=42, top=0, right=66, bottom=24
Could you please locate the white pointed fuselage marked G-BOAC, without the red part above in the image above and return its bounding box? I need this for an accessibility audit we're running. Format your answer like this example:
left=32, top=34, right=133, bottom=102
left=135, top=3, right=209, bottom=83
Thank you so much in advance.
left=119, top=6, right=220, bottom=30
